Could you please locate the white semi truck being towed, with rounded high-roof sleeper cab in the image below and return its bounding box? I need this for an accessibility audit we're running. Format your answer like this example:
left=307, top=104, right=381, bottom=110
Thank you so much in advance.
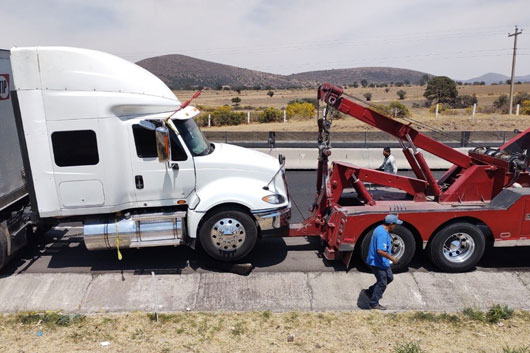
left=0, top=47, right=290, bottom=268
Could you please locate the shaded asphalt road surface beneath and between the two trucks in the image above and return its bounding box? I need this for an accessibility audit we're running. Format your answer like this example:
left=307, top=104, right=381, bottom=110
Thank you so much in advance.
left=0, top=171, right=530, bottom=276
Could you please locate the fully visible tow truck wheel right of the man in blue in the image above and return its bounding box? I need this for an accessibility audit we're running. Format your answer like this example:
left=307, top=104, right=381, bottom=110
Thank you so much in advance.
left=426, top=222, right=486, bottom=272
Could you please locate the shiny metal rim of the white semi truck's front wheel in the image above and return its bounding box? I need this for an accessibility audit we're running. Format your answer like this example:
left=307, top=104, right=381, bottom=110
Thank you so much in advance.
left=210, top=218, right=247, bottom=251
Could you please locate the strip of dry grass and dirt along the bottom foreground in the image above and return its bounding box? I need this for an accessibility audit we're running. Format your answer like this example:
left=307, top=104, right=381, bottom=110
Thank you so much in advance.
left=0, top=311, right=530, bottom=353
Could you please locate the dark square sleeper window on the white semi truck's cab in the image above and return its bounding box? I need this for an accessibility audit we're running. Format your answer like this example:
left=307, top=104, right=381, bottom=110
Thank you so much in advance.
left=52, top=130, right=99, bottom=167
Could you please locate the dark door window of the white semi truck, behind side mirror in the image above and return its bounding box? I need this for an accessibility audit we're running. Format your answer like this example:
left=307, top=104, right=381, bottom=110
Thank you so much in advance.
left=132, top=124, right=188, bottom=161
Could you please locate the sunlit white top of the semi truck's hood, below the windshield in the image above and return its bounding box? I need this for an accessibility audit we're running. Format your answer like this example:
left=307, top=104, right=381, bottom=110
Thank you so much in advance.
left=194, top=143, right=280, bottom=175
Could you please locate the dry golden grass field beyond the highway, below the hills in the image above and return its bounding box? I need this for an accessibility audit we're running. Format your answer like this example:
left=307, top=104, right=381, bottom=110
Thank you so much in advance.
left=175, top=84, right=530, bottom=131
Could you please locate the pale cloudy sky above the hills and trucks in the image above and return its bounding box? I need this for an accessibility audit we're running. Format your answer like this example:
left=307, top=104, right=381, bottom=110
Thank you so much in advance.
left=0, top=0, right=530, bottom=79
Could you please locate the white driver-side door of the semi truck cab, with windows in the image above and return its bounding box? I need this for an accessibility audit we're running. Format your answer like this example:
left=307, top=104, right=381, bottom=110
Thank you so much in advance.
left=129, top=123, right=195, bottom=207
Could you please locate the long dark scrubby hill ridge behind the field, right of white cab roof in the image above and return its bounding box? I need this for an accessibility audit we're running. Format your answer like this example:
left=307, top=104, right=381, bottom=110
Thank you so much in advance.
left=137, top=54, right=434, bottom=89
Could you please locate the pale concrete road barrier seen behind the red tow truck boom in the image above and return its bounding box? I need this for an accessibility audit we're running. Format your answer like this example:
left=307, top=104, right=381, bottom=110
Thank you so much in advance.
left=255, top=147, right=470, bottom=170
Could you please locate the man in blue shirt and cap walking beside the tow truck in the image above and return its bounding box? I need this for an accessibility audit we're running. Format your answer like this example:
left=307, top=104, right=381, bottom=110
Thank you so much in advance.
left=366, top=214, right=403, bottom=310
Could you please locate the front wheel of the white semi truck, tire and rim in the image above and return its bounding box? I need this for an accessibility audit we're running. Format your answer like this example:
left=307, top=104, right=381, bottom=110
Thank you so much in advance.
left=199, top=209, right=258, bottom=262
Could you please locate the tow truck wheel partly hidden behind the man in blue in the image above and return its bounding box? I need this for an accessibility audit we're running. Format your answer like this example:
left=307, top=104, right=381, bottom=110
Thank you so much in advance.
left=361, top=225, right=416, bottom=272
